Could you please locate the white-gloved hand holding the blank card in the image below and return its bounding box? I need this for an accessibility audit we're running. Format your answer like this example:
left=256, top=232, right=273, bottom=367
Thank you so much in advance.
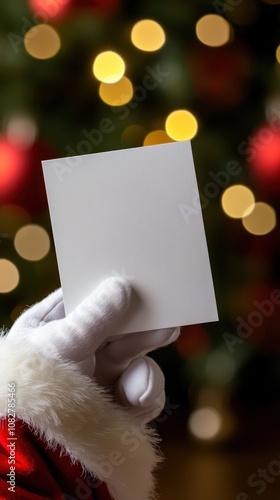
left=9, top=278, right=179, bottom=422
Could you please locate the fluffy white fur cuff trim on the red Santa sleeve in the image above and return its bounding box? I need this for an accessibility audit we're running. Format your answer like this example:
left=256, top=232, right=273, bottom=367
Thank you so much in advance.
left=0, top=335, right=161, bottom=500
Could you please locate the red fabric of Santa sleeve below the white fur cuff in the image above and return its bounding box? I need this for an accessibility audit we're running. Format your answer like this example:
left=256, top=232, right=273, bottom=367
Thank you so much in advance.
left=0, top=419, right=111, bottom=500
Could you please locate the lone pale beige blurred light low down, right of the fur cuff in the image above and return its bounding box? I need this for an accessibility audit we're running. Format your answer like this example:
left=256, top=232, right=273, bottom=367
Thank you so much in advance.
left=188, top=407, right=222, bottom=440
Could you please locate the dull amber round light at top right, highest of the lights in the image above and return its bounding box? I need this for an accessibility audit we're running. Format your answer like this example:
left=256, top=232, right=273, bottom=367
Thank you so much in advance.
left=196, top=14, right=231, bottom=47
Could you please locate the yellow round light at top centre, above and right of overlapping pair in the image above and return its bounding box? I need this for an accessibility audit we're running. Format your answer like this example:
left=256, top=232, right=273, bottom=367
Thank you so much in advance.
left=131, top=19, right=165, bottom=52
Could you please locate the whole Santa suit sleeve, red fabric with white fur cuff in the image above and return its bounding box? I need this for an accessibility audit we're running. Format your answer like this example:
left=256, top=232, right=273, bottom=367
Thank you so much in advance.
left=0, top=335, right=160, bottom=500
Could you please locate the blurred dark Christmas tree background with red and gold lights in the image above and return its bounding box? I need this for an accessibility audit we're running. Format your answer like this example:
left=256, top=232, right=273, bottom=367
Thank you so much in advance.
left=0, top=0, right=280, bottom=500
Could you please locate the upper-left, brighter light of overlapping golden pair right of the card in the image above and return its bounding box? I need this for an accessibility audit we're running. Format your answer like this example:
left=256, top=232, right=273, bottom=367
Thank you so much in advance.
left=221, top=184, right=255, bottom=219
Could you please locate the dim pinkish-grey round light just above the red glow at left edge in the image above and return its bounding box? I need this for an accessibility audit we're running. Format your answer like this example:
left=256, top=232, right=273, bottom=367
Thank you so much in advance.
left=6, top=115, right=37, bottom=149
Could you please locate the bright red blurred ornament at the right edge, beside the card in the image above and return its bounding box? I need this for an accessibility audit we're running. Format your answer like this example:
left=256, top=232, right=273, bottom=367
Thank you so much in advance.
left=244, top=124, right=280, bottom=193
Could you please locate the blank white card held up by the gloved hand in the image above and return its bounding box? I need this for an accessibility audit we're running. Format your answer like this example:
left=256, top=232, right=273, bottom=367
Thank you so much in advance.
left=42, top=141, right=218, bottom=333
